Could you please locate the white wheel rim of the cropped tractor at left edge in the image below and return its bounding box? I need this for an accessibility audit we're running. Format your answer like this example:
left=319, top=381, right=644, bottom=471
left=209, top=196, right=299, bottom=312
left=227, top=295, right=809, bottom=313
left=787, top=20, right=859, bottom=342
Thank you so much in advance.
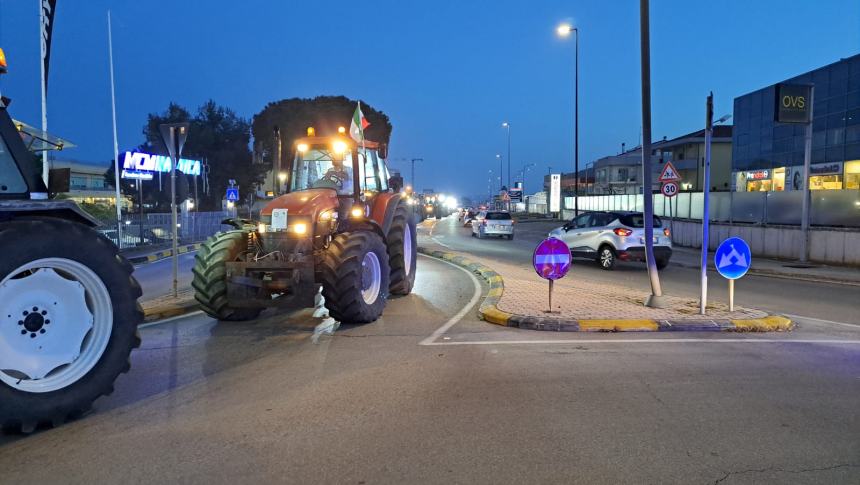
left=0, top=258, right=113, bottom=393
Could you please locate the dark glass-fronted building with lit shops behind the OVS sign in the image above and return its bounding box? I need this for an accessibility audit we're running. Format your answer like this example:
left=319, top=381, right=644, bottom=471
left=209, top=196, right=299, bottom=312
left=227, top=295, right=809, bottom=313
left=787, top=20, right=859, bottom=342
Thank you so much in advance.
left=732, top=54, right=860, bottom=192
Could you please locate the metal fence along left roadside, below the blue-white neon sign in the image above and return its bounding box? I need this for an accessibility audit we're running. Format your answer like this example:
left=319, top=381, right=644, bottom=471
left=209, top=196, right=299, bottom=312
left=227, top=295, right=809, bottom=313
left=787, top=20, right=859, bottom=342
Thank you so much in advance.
left=96, top=211, right=230, bottom=249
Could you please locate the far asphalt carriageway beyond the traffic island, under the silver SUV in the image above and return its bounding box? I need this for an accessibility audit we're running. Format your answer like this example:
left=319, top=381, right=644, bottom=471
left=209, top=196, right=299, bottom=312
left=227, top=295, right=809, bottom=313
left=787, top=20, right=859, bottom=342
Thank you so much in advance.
left=430, top=218, right=860, bottom=325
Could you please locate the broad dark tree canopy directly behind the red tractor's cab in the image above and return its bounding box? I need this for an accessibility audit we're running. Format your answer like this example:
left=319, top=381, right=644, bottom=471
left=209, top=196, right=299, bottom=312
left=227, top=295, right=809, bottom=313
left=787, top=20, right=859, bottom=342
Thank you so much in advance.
left=252, top=96, right=392, bottom=174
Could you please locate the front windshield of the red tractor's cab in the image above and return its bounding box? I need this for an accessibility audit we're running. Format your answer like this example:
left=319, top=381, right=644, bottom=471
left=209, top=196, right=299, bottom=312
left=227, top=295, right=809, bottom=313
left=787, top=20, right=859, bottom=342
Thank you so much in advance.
left=290, top=148, right=353, bottom=195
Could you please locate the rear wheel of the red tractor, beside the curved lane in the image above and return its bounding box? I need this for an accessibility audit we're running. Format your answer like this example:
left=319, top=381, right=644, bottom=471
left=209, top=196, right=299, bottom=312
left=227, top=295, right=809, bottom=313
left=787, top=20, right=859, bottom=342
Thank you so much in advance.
left=387, top=205, right=418, bottom=295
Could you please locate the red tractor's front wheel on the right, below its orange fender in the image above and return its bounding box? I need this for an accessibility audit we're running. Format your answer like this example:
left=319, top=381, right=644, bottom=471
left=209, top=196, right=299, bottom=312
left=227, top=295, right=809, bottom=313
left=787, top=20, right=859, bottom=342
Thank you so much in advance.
left=318, top=231, right=391, bottom=323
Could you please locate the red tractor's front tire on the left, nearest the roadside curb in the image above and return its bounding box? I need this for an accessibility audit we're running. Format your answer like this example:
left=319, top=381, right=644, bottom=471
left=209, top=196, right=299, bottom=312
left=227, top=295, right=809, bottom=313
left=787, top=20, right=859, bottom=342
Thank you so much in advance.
left=191, top=230, right=263, bottom=321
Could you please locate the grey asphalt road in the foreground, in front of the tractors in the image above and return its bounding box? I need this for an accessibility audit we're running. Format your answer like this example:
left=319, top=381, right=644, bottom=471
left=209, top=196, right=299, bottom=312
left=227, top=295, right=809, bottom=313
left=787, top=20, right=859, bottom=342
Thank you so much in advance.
left=0, top=224, right=860, bottom=484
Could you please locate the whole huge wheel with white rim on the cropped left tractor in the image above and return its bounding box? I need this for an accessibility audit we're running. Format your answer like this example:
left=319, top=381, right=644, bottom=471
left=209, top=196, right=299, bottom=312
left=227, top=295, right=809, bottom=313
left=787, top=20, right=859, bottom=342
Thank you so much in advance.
left=0, top=217, right=143, bottom=433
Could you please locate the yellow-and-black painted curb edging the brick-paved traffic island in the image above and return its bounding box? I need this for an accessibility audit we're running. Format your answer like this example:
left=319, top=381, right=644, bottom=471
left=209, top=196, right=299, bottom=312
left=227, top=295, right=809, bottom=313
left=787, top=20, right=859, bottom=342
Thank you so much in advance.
left=418, top=246, right=794, bottom=332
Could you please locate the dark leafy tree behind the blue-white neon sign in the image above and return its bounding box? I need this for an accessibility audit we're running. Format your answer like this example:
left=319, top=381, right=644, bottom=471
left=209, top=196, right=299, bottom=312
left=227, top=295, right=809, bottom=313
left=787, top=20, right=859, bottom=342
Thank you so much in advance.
left=105, top=100, right=264, bottom=210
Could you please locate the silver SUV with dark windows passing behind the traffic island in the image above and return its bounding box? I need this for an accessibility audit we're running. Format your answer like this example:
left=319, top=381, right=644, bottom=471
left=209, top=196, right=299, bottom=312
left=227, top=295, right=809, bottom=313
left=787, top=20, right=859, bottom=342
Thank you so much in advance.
left=549, top=211, right=672, bottom=270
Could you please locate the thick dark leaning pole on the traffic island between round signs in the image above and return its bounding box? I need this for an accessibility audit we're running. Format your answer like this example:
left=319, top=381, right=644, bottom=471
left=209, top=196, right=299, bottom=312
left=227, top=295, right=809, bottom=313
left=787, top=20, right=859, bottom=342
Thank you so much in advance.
left=639, top=0, right=665, bottom=308
